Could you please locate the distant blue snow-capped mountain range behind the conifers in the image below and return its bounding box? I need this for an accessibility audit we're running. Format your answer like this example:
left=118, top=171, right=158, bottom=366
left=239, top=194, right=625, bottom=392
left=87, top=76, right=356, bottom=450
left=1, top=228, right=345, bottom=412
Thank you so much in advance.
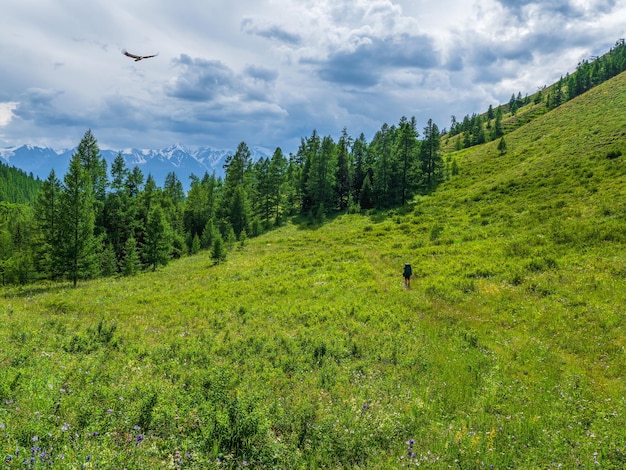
left=0, top=144, right=272, bottom=189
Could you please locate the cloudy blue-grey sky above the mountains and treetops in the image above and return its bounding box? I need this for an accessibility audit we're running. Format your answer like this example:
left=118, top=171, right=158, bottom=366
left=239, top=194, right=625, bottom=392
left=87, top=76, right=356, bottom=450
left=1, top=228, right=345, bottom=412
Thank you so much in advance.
left=0, top=0, right=626, bottom=153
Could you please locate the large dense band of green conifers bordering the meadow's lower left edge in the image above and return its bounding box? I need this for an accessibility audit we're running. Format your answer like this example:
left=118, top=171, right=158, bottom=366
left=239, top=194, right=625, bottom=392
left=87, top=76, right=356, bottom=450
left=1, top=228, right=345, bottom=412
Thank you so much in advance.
left=0, top=117, right=448, bottom=285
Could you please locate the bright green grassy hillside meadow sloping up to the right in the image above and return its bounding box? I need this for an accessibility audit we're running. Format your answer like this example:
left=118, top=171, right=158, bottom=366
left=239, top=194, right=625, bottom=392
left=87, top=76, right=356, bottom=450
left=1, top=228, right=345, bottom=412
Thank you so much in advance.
left=0, top=74, right=626, bottom=469
